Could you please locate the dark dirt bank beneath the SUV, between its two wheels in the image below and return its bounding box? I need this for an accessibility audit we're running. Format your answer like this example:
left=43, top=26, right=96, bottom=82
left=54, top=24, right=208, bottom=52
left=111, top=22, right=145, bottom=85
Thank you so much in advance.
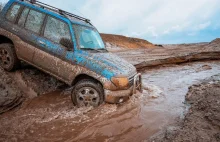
left=0, top=64, right=66, bottom=114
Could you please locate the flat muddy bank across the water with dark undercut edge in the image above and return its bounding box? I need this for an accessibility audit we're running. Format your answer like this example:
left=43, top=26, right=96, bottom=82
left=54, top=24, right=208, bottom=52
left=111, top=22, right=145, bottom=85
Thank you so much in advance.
left=115, top=39, right=220, bottom=69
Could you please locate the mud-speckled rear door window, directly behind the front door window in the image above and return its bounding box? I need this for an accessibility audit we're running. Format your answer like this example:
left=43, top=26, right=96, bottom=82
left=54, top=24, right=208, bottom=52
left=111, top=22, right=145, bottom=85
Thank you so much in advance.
left=25, top=10, right=45, bottom=33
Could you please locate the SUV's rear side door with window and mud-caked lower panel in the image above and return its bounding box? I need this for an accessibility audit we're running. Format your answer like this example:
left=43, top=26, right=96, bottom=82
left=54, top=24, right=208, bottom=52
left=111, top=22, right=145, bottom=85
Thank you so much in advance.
left=14, top=7, right=45, bottom=63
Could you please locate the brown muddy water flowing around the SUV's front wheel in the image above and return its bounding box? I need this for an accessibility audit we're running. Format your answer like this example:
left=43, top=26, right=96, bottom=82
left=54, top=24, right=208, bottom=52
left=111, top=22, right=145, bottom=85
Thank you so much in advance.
left=0, top=61, right=220, bottom=142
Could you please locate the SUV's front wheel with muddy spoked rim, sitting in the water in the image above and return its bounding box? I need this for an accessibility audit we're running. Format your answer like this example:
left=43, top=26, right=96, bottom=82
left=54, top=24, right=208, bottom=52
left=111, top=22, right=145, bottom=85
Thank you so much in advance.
left=71, top=79, right=104, bottom=107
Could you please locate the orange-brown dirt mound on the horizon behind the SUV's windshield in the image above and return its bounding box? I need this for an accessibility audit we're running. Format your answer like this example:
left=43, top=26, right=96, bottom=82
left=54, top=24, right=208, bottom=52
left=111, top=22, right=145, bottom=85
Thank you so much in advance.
left=101, top=34, right=155, bottom=48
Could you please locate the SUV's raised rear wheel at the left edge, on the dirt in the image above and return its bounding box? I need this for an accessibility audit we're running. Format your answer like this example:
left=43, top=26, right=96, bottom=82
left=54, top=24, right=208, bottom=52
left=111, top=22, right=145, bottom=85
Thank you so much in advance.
left=0, top=43, right=20, bottom=71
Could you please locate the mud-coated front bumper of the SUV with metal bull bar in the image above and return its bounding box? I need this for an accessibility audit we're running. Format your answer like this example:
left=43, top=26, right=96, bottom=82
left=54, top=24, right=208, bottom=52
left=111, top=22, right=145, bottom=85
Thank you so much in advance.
left=105, top=73, right=142, bottom=104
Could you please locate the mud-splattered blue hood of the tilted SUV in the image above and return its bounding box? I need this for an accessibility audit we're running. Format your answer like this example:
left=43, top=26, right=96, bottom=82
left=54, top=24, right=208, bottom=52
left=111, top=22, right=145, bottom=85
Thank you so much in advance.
left=75, top=51, right=137, bottom=79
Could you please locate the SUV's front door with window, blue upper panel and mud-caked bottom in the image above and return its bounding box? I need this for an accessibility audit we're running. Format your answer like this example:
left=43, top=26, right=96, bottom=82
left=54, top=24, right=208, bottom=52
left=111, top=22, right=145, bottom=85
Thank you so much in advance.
left=33, top=15, right=75, bottom=82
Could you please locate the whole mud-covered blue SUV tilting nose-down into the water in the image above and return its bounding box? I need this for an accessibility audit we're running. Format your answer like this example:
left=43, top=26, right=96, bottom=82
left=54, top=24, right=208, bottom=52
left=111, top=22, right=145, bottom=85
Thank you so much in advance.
left=0, top=0, right=141, bottom=105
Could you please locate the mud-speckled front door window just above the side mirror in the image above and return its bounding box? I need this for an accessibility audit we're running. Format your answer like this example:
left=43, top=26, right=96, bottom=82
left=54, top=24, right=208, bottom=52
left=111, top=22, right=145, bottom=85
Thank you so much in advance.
left=44, top=16, right=71, bottom=43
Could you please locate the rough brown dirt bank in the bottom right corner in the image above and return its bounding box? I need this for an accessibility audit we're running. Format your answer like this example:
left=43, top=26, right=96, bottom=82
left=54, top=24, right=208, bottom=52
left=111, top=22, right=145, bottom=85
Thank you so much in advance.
left=152, top=75, right=220, bottom=142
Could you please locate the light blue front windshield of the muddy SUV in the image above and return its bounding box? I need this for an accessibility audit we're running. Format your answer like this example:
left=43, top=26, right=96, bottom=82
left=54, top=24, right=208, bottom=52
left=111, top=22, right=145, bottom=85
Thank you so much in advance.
left=73, top=24, right=105, bottom=49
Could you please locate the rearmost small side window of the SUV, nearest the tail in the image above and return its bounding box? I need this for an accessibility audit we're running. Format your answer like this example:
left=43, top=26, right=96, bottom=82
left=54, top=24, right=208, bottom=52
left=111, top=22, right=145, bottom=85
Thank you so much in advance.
left=6, top=4, right=21, bottom=22
